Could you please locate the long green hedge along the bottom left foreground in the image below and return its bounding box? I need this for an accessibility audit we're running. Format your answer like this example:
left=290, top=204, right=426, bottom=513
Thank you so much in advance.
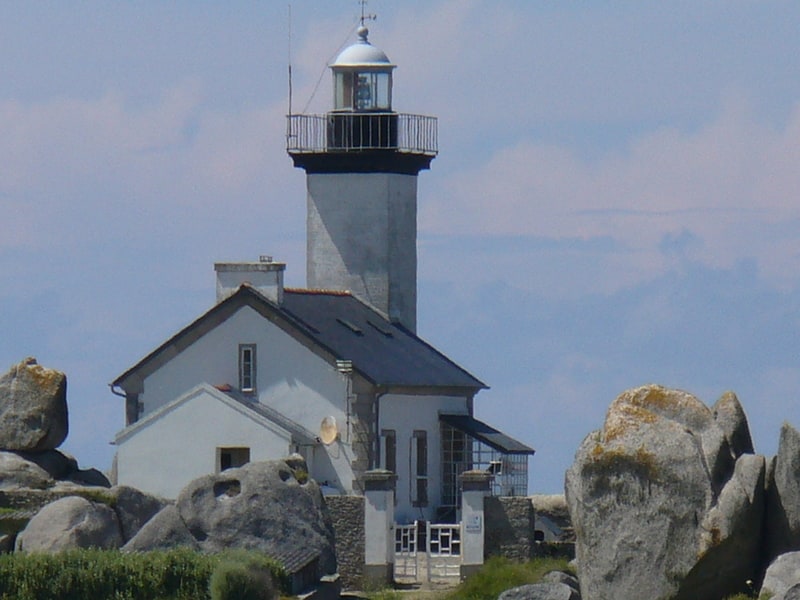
left=0, top=549, right=284, bottom=600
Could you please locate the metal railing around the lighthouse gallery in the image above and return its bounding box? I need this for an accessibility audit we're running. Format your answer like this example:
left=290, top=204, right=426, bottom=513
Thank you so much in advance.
left=286, top=112, right=439, bottom=156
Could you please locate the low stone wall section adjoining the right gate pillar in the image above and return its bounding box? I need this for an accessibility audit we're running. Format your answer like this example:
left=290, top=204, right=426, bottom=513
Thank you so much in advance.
left=483, top=496, right=536, bottom=561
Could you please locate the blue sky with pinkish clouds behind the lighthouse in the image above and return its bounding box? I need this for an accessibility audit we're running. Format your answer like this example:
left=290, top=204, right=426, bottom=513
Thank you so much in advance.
left=0, top=0, right=800, bottom=493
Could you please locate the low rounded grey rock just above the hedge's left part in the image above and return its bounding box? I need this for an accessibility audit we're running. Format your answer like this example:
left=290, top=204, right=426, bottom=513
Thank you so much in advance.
left=16, top=496, right=122, bottom=552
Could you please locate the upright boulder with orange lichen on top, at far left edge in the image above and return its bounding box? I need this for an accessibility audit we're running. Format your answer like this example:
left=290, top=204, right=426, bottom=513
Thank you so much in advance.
left=0, top=358, right=68, bottom=451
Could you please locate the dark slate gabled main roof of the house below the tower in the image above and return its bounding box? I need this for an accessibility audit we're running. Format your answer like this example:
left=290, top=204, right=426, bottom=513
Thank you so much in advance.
left=112, top=284, right=487, bottom=393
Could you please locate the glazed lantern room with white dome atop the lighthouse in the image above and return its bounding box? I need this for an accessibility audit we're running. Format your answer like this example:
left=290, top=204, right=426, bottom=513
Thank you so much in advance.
left=330, top=25, right=395, bottom=112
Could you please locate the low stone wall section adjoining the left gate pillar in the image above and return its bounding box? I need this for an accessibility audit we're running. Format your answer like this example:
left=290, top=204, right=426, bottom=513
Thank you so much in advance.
left=325, top=496, right=364, bottom=590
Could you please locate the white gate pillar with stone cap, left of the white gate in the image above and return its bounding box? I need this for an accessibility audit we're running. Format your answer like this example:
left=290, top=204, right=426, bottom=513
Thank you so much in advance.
left=364, top=469, right=397, bottom=585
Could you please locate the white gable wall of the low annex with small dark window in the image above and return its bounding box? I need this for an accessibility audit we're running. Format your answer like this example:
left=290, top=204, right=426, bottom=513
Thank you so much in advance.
left=117, top=389, right=291, bottom=498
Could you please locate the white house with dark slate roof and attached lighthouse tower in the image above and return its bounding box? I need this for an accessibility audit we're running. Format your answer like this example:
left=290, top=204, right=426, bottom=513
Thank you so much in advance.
left=112, top=27, right=533, bottom=521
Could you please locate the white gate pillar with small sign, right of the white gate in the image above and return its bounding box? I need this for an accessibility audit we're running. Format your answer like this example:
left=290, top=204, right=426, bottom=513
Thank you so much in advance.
left=460, top=471, right=492, bottom=579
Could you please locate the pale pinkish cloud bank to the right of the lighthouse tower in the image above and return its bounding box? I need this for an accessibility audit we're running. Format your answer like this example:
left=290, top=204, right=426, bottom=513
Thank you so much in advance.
left=420, top=97, right=800, bottom=296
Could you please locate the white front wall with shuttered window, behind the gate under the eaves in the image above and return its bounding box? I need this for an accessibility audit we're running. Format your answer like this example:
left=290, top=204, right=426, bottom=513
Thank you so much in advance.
left=378, top=394, right=468, bottom=523
